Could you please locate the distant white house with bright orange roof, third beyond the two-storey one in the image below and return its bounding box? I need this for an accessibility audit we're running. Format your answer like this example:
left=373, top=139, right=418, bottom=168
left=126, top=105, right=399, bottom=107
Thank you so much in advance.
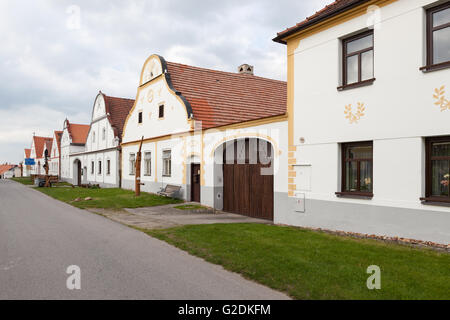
left=60, top=119, right=90, bottom=184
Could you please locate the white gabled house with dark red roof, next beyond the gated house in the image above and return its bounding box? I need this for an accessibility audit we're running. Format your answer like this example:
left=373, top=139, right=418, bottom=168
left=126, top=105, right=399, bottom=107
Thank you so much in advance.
left=69, top=92, right=134, bottom=187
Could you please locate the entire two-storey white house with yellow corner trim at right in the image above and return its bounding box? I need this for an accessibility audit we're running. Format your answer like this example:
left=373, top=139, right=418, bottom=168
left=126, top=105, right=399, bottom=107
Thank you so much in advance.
left=274, top=0, right=450, bottom=243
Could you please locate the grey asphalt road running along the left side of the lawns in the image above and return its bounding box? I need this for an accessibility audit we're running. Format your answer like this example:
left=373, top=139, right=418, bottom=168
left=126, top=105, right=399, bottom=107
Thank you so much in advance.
left=0, top=180, right=287, bottom=300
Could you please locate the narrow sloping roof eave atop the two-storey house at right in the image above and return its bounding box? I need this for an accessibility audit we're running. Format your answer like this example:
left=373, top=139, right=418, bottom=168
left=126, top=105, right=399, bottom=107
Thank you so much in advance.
left=273, top=0, right=369, bottom=43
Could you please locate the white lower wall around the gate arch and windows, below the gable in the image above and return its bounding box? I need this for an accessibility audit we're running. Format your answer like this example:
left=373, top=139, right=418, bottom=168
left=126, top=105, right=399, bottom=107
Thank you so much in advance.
left=122, top=121, right=287, bottom=207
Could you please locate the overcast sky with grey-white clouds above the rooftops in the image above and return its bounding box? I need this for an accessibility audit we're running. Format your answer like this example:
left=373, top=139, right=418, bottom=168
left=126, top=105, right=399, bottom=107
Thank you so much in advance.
left=0, top=0, right=332, bottom=163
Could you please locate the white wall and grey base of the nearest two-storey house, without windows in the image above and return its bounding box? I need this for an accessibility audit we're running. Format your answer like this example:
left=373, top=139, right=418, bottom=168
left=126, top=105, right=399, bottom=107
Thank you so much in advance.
left=275, top=0, right=450, bottom=243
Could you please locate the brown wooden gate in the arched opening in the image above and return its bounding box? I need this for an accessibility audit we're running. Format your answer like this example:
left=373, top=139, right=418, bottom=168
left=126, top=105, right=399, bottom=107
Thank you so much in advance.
left=223, top=139, right=273, bottom=220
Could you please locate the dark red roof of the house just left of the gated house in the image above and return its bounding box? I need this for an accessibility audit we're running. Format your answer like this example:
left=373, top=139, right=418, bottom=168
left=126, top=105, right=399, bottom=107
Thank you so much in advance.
left=100, top=92, right=134, bottom=139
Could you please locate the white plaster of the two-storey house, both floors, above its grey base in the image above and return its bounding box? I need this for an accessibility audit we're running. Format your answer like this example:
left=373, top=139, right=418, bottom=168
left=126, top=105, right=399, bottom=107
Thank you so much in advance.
left=294, top=0, right=450, bottom=211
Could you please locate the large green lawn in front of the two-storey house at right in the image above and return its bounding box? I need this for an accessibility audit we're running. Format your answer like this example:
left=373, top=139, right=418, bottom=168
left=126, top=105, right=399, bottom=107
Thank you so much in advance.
left=145, top=224, right=450, bottom=299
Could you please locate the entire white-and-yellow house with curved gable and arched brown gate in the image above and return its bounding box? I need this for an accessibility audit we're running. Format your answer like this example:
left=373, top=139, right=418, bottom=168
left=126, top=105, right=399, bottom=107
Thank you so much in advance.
left=122, top=55, right=288, bottom=220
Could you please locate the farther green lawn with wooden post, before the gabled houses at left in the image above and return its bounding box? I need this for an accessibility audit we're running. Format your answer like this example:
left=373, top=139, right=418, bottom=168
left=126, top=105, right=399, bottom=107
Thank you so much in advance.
left=36, top=187, right=183, bottom=209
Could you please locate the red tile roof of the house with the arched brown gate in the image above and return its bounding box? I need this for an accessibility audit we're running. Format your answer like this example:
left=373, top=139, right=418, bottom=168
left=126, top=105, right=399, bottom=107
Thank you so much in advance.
left=167, top=62, right=287, bottom=129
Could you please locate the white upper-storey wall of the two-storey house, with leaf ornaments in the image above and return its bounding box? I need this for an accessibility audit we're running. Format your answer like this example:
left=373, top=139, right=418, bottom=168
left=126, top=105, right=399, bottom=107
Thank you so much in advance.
left=294, top=0, right=450, bottom=144
